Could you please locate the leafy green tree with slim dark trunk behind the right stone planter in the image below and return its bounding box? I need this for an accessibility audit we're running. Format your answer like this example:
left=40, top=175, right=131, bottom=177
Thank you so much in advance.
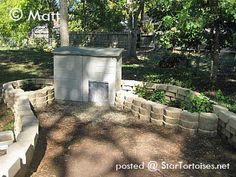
left=148, top=0, right=236, bottom=86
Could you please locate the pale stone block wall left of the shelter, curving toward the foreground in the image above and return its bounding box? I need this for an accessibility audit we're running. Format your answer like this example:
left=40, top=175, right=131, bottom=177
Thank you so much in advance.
left=0, top=79, right=54, bottom=177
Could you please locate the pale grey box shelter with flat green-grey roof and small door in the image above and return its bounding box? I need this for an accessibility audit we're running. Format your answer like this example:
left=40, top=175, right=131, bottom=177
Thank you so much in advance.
left=53, top=47, right=122, bottom=104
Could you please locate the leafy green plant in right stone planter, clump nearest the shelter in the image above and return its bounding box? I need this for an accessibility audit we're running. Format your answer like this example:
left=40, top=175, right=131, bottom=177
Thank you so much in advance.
left=135, top=85, right=165, bottom=103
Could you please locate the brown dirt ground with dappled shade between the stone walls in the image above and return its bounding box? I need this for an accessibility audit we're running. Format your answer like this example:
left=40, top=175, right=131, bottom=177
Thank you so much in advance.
left=27, top=103, right=236, bottom=177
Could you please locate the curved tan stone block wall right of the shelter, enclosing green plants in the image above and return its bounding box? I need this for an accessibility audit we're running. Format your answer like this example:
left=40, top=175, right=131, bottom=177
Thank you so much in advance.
left=115, top=80, right=236, bottom=148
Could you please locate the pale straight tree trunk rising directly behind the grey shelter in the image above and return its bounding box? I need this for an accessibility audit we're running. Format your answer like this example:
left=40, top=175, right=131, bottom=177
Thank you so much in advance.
left=60, top=0, right=69, bottom=46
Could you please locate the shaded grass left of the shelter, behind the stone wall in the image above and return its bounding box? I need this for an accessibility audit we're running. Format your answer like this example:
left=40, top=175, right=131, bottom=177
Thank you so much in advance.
left=0, top=50, right=53, bottom=83
